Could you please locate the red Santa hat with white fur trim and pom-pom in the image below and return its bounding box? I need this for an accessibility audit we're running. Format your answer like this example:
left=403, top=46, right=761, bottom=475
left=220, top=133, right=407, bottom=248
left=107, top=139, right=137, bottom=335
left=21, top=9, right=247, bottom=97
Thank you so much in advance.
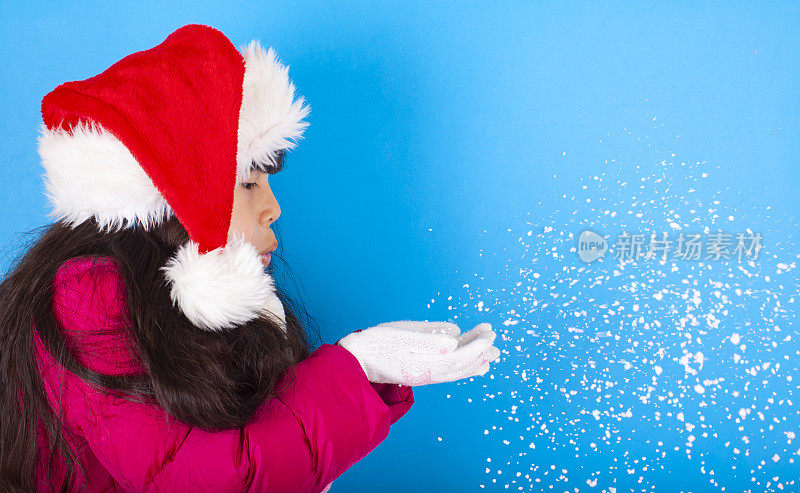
left=39, top=24, right=310, bottom=330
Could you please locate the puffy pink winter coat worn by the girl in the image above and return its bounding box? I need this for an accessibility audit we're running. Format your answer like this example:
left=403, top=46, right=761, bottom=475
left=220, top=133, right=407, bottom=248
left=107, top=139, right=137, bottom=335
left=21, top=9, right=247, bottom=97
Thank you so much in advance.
left=34, top=257, right=414, bottom=492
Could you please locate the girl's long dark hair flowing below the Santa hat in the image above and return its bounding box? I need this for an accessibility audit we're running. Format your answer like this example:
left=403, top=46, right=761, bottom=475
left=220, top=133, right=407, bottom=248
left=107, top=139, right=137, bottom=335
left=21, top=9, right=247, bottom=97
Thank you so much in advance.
left=0, top=199, right=319, bottom=492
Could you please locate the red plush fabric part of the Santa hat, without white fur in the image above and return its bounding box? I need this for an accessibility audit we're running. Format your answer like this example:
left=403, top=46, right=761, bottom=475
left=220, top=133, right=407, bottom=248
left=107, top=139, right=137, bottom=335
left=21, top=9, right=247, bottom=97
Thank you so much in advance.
left=41, top=24, right=245, bottom=254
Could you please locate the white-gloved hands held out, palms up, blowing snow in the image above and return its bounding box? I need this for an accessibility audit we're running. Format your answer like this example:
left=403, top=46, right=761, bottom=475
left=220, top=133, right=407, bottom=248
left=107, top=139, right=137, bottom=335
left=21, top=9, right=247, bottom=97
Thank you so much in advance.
left=337, top=320, right=500, bottom=386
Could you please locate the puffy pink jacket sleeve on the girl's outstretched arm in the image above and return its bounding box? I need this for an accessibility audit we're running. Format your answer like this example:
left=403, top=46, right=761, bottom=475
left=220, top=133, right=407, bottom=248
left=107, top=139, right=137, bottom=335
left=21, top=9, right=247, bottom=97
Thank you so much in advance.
left=37, top=258, right=414, bottom=492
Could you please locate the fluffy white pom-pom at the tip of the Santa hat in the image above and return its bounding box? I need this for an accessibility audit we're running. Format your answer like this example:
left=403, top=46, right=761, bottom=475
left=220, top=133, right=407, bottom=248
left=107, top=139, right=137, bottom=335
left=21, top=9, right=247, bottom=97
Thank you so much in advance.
left=161, top=235, right=285, bottom=330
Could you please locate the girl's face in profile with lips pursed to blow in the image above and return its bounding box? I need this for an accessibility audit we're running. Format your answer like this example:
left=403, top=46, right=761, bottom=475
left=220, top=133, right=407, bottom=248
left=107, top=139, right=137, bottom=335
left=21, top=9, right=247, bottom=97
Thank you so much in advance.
left=228, top=170, right=281, bottom=267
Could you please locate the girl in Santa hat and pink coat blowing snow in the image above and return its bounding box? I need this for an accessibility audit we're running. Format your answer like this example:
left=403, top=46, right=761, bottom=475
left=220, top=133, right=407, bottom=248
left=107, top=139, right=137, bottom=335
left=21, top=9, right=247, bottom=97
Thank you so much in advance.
left=0, top=25, right=499, bottom=492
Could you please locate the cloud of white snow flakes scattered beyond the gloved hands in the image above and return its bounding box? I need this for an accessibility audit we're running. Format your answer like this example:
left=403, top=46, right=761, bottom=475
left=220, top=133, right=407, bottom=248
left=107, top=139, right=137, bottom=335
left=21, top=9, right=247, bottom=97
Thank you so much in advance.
left=428, top=118, right=800, bottom=492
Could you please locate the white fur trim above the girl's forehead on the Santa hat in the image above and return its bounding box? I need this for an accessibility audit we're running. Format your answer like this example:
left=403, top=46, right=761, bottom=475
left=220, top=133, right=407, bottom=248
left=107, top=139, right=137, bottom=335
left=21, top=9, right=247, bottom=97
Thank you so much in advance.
left=236, top=40, right=311, bottom=182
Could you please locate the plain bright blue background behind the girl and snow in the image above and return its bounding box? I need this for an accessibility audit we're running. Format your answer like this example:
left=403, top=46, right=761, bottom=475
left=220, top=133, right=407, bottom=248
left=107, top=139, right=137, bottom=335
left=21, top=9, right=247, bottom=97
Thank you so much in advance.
left=0, top=1, right=800, bottom=492
